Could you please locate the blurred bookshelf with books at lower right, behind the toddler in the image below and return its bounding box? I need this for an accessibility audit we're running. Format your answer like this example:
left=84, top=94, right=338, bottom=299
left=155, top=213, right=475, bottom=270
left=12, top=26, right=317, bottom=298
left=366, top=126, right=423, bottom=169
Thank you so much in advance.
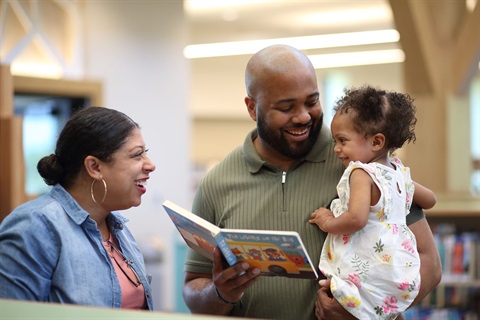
left=405, top=195, right=480, bottom=320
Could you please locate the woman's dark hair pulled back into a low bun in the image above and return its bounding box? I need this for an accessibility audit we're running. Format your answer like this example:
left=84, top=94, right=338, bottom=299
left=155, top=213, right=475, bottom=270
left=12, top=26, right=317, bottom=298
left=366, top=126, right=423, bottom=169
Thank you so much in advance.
left=37, top=107, right=139, bottom=188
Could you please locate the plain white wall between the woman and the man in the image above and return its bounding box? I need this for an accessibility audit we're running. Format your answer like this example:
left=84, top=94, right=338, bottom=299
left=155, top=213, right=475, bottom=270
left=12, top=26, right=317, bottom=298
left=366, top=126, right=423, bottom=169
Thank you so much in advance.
left=83, top=0, right=190, bottom=310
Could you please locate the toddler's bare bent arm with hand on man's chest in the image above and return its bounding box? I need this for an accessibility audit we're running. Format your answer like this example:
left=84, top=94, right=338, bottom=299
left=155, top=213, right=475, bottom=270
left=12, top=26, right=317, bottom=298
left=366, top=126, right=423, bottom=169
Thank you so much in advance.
left=309, top=169, right=376, bottom=234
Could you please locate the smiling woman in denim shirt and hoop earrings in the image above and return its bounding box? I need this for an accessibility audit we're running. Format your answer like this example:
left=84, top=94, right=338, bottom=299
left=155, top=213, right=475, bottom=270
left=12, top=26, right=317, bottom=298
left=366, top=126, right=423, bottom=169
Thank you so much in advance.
left=0, top=107, right=155, bottom=310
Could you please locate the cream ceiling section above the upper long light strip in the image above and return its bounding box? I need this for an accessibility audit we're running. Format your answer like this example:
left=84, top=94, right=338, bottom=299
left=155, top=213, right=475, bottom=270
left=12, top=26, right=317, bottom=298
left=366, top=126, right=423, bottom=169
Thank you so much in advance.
left=184, top=0, right=395, bottom=44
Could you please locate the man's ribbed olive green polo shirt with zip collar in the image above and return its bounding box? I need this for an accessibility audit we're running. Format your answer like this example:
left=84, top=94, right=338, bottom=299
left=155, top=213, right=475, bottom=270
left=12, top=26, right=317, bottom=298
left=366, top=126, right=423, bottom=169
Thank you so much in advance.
left=185, top=126, right=423, bottom=320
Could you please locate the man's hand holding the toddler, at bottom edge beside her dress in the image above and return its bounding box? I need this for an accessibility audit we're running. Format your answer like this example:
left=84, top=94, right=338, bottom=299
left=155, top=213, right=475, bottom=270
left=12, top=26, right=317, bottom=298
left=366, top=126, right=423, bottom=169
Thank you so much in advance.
left=315, top=279, right=356, bottom=320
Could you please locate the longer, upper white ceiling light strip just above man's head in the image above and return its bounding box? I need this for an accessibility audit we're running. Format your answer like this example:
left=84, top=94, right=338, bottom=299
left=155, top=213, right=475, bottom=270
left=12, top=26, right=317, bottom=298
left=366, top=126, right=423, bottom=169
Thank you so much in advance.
left=183, top=29, right=400, bottom=59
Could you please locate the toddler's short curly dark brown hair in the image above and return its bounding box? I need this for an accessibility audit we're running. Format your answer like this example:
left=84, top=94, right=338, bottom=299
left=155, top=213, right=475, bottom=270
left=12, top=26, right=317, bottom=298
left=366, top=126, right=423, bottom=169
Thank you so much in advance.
left=333, top=85, right=417, bottom=154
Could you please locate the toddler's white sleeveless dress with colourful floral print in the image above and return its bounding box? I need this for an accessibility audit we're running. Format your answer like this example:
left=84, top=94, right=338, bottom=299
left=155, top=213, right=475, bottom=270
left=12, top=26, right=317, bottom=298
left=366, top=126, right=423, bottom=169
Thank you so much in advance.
left=319, top=158, right=420, bottom=320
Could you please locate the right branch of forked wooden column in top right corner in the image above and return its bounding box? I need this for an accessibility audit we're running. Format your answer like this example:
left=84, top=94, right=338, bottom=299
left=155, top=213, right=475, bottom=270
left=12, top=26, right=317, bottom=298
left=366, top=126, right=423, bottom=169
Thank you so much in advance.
left=450, top=3, right=480, bottom=95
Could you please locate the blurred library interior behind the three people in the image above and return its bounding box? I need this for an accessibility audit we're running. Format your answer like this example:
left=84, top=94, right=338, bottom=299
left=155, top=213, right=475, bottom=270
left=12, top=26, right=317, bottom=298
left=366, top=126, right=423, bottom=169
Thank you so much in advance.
left=0, top=0, right=480, bottom=319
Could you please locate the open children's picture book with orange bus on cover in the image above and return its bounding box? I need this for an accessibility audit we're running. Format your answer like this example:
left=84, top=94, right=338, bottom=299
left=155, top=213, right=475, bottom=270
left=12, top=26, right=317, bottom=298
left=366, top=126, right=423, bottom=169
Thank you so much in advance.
left=163, top=200, right=318, bottom=280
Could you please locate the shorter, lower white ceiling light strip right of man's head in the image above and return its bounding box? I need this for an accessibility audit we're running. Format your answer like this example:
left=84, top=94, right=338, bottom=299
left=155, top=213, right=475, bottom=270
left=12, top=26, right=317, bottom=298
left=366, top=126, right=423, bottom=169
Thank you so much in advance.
left=308, top=49, right=405, bottom=69
